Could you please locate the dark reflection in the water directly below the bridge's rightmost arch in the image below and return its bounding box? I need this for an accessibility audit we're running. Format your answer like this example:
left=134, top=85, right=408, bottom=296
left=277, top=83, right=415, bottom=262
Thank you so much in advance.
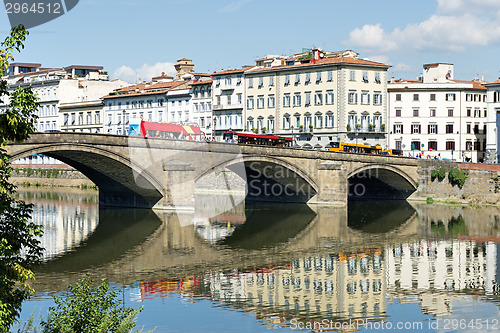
left=347, top=200, right=416, bottom=234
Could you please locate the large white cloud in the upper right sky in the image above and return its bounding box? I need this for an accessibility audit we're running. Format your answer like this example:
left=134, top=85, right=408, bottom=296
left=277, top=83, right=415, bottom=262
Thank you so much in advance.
left=346, top=0, right=500, bottom=53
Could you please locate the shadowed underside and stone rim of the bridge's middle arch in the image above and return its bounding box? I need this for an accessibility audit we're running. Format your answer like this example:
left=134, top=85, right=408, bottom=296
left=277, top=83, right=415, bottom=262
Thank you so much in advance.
left=195, top=155, right=319, bottom=203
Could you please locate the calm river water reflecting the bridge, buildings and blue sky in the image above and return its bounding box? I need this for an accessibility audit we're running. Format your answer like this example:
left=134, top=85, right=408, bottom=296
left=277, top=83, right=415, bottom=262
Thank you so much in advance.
left=13, top=189, right=500, bottom=332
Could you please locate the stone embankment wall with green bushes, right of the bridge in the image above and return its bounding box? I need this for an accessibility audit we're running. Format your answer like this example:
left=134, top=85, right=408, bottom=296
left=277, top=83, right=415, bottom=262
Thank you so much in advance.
left=411, top=161, right=500, bottom=205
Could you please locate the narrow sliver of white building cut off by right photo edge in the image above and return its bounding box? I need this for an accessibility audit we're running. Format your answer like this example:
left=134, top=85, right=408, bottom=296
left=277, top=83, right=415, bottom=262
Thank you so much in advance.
left=485, top=79, right=500, bottom=163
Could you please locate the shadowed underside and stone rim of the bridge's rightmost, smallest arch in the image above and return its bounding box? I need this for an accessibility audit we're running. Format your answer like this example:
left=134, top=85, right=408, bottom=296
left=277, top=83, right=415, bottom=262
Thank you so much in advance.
left=347, top=164, right=417, bottom=200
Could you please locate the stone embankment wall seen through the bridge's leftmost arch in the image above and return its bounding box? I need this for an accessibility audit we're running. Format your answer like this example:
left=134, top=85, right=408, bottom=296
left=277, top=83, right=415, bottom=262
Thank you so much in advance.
left=10, top=168, right=95, bottom=188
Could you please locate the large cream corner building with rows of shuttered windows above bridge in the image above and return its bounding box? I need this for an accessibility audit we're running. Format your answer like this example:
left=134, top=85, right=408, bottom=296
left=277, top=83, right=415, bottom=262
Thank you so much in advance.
left=245, top=49, right=389, bottom=149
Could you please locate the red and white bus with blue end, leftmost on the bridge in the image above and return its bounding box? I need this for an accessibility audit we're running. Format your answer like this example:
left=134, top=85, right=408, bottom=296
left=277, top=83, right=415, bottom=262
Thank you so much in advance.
left=128, top=119, right=205, bottom=141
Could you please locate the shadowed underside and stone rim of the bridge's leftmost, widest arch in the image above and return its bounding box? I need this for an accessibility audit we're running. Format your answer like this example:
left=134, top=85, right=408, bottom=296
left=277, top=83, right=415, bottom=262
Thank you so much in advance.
left=10, top=143, right=163, bottom=208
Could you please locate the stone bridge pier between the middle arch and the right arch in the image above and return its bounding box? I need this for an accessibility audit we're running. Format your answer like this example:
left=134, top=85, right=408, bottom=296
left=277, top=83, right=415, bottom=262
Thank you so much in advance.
left=308, top=161, right=349, bottom=206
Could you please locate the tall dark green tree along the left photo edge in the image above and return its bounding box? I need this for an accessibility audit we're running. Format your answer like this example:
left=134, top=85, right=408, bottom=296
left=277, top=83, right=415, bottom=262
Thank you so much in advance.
left=0, top=25, right=42, bottom=332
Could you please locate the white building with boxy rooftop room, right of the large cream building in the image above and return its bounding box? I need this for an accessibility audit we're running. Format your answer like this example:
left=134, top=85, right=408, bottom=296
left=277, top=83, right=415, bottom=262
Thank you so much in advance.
left=388, top=63, right=487, bottom=162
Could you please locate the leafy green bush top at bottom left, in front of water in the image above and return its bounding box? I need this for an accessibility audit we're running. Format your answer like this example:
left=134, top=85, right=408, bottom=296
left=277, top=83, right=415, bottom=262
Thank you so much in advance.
left=41, top=276, right=142, bottom=333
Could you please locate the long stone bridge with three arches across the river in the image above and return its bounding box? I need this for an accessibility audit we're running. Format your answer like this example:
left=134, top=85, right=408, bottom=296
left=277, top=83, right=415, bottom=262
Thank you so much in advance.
left=7, top=133, right=430, bottom=210
